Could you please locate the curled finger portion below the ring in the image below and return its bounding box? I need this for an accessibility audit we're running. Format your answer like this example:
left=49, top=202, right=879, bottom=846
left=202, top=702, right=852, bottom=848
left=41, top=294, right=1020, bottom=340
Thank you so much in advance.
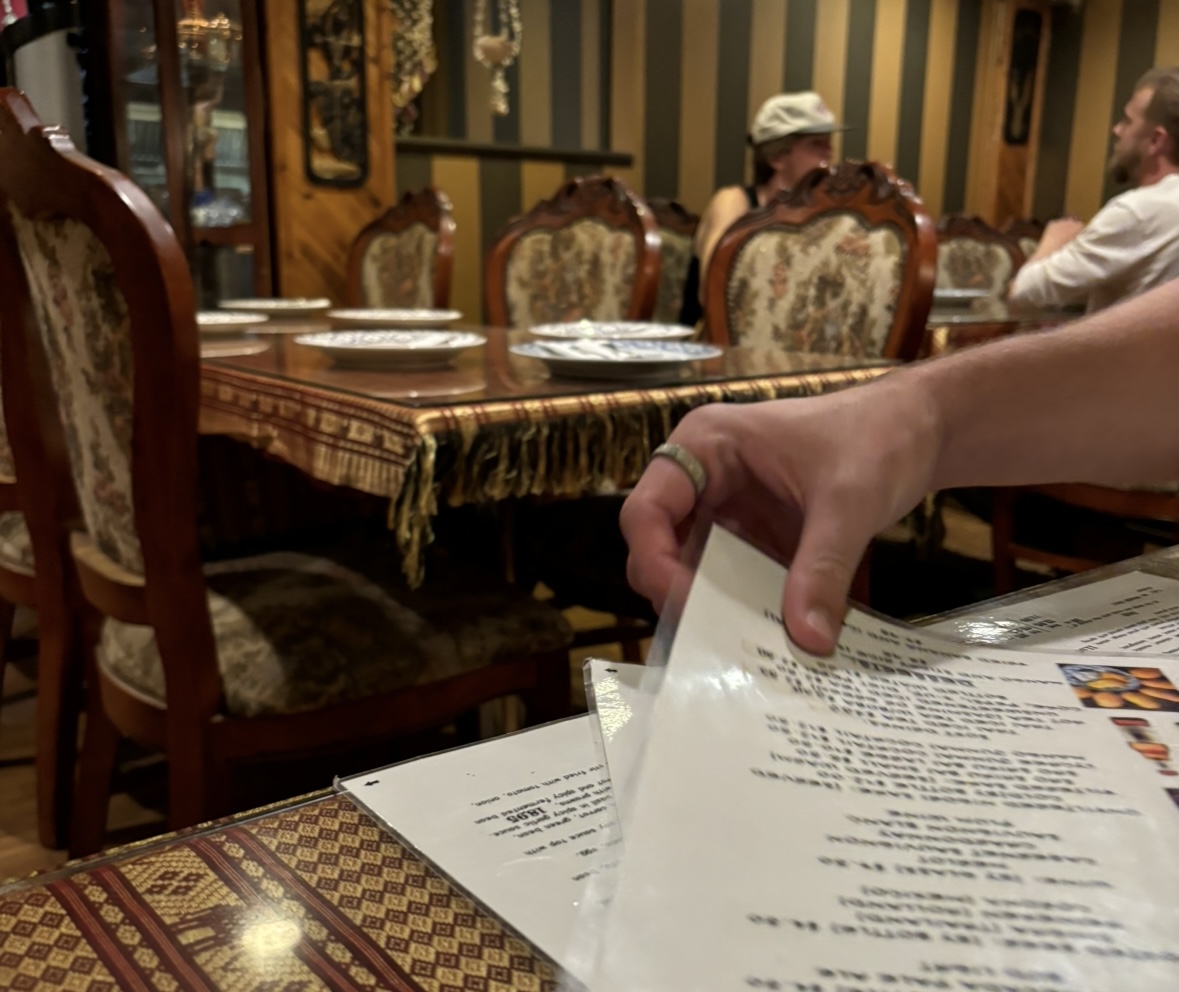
left=618, top=458, right=696, bottom=611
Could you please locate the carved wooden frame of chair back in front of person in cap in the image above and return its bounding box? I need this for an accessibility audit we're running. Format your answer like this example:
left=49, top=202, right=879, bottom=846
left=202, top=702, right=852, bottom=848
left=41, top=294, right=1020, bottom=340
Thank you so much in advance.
left=704, top=159, right=937, bottom=361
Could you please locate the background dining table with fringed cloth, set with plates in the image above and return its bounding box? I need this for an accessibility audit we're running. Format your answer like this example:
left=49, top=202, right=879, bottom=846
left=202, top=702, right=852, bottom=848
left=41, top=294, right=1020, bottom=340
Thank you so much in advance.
left=200, top=320, right=895, bottom=585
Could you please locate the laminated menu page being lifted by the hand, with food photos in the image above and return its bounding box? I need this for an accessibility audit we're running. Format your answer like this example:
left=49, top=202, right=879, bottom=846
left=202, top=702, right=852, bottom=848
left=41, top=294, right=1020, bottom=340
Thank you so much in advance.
left=579, top=530, right=1179, bottom=992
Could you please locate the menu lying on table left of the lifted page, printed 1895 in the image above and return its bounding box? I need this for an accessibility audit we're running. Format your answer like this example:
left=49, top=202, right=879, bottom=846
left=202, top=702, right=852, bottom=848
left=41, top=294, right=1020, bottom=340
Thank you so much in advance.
left=336, top=662, right=651, bottom=970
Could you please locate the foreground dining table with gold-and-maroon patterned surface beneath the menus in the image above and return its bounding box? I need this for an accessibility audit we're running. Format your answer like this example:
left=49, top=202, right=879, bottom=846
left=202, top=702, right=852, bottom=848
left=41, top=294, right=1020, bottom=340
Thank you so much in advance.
left=0, top=547, right=1179, bottom=992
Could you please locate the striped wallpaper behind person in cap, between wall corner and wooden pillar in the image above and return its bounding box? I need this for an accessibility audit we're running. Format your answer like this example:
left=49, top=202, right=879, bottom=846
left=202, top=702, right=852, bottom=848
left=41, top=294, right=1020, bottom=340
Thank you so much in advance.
left=612, top=0, right=982, bottom=213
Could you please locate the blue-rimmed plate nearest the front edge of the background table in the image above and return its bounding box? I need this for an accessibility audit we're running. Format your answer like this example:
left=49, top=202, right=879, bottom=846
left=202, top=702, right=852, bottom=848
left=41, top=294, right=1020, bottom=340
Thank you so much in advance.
left=511, top=340, right=724, bottom=379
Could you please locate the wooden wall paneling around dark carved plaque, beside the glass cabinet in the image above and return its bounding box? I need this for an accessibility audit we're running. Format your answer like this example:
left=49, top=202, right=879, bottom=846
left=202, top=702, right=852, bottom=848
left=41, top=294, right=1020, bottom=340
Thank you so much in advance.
left=265, top=0, right=395, bottom=303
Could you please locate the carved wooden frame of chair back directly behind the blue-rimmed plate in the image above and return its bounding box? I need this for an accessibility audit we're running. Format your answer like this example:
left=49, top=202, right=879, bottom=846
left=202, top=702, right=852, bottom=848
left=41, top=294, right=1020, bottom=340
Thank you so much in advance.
left=483, top=176, right=660, bottom=327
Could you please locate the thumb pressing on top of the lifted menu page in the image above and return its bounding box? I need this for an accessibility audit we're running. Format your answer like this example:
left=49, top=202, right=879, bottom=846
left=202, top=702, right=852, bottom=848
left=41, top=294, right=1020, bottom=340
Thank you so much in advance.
left=782, top=497, right=875, bottom=655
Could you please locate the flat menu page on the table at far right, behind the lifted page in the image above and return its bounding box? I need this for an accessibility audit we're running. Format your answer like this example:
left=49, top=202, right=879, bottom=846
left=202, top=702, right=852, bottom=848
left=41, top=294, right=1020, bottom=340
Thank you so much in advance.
left=927, top=572, right=1179, bottom=655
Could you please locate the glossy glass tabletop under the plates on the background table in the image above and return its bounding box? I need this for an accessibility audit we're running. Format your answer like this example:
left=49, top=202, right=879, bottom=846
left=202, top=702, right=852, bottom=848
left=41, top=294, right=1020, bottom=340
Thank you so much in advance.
left=202, top=321, right=894, bottom=407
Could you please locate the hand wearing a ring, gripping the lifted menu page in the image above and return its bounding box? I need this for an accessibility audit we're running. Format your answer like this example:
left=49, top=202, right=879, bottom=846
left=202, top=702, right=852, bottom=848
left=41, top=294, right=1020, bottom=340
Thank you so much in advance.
left=620, top=382, right=940, bottom=655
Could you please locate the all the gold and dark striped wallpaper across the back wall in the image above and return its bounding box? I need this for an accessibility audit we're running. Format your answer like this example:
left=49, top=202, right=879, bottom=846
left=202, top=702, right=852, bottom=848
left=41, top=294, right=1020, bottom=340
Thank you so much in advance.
left=397, top=0, right=1179, bottom=315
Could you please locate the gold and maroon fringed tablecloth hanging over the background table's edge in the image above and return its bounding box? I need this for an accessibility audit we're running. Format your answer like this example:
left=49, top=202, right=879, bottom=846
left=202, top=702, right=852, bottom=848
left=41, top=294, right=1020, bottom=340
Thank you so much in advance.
left=200, top=351, right=889, bottom=583
